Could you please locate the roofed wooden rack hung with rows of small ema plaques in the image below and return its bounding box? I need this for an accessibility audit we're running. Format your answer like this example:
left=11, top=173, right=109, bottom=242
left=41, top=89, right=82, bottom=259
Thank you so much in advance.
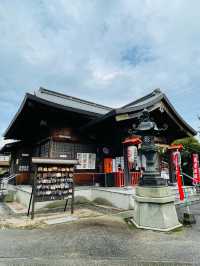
left=27, top=157, right=77, bottom=219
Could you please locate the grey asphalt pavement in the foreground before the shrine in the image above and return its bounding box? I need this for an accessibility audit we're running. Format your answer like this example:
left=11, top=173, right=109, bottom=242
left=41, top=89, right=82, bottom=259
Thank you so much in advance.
left=0, top=204, right=200, bottom=266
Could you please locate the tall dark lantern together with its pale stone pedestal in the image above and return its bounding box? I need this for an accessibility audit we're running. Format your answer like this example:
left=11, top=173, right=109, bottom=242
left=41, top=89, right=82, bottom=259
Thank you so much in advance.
left=132, top=109, right=182, bottom=231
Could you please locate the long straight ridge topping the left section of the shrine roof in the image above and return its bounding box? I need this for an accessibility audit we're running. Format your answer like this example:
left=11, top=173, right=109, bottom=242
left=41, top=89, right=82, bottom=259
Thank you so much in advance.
left=36, top=87, right=113, bottom=111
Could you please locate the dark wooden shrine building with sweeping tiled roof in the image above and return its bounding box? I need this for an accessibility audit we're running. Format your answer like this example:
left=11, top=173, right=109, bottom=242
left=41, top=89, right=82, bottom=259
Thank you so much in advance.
left=1, top=88, right=197, bottom=186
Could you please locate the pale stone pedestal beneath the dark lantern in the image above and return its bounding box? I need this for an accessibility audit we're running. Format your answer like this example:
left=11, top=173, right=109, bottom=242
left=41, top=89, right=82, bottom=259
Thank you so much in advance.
left=133, top=186, right=182, bottom=231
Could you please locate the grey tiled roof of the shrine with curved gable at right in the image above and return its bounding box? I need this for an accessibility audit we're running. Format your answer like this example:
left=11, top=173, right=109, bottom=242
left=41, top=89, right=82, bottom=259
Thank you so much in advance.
left=4, top=88, right=197, bottom=141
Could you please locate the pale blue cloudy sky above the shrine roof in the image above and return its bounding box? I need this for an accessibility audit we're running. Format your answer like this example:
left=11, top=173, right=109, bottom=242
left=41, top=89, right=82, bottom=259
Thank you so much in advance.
left=0, top=0, right=200, bottom=145
